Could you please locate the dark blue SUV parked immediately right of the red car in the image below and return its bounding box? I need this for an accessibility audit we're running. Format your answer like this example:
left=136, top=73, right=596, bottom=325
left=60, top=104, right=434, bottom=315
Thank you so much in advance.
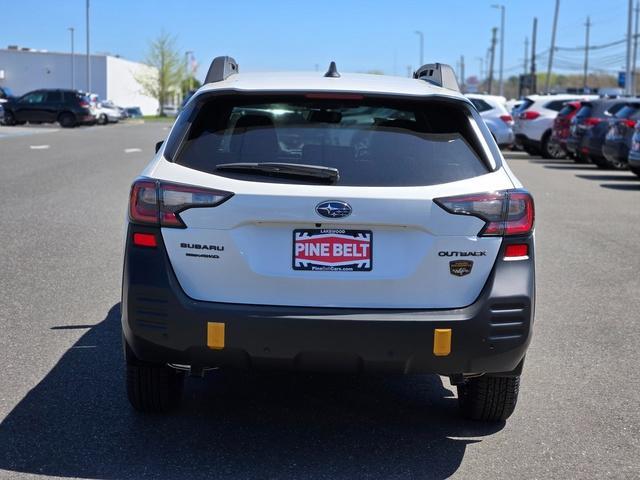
left=567, top=98, right=627, bottom=165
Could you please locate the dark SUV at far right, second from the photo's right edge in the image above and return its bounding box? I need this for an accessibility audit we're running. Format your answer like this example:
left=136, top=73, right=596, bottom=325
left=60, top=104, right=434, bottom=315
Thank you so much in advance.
left=602, top=102, right=640, bottom=170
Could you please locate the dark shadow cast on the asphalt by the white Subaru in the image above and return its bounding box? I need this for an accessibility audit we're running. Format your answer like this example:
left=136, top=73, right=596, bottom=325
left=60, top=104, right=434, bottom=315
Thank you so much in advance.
left=0, top=304, right=504, bottom=479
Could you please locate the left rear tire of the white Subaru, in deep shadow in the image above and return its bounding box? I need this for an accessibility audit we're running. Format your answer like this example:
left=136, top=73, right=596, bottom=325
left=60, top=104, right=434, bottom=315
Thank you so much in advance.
left=125, top=343, right=184, bottom=413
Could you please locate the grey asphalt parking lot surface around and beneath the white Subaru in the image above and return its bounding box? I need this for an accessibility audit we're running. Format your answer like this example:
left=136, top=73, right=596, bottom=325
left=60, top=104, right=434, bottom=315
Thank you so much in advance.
left=0, top=123, right=640, bottom=479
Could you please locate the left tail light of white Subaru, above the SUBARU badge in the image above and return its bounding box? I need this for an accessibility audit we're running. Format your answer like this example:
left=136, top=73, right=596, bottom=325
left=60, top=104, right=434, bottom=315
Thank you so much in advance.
left=129, top=180, right=233, bottom=228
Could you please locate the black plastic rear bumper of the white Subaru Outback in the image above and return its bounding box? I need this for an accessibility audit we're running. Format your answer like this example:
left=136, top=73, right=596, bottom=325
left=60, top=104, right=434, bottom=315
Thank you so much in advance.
left=122, top=226, right=535, bottom=375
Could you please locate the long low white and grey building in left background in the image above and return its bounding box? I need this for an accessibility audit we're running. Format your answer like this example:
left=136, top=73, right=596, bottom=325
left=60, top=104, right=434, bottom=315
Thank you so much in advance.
left=0, top=47, right=158, bottom=115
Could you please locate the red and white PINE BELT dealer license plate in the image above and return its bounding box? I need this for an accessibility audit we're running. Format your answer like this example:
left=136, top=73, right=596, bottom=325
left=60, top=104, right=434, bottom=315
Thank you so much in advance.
left=293, top=228, right=373, bottom=272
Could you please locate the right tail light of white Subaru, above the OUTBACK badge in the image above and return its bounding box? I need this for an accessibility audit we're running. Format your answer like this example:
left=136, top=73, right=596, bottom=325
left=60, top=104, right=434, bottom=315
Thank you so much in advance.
left=434, top=190, right=535, bottom=237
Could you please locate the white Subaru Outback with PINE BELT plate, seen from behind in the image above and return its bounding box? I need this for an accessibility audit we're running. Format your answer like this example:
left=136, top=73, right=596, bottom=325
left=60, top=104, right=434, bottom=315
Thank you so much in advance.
left=122, top=57, right=535, bottom=421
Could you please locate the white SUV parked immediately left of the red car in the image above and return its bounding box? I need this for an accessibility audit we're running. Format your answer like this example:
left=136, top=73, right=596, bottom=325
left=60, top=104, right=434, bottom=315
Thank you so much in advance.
left=513, top=94, right=596, bottom=158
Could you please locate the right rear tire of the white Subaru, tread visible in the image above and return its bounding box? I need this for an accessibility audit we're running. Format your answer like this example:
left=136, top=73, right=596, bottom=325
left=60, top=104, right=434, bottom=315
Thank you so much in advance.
left=458, top=376, right=520, bottom=422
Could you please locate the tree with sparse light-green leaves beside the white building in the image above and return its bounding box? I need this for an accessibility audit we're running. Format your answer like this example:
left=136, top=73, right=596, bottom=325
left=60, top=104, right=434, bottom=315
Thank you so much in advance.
left=136, top=31, right=184, bottom=116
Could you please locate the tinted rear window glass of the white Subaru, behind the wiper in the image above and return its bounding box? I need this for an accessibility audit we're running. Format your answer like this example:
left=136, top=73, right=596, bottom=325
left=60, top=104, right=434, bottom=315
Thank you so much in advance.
left=173, top=96, right=488, bottom=186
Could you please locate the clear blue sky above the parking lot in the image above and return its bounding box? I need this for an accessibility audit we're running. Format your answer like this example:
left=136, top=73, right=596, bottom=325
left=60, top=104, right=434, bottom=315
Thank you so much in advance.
left=0, top=0, right=627, bottom=77
